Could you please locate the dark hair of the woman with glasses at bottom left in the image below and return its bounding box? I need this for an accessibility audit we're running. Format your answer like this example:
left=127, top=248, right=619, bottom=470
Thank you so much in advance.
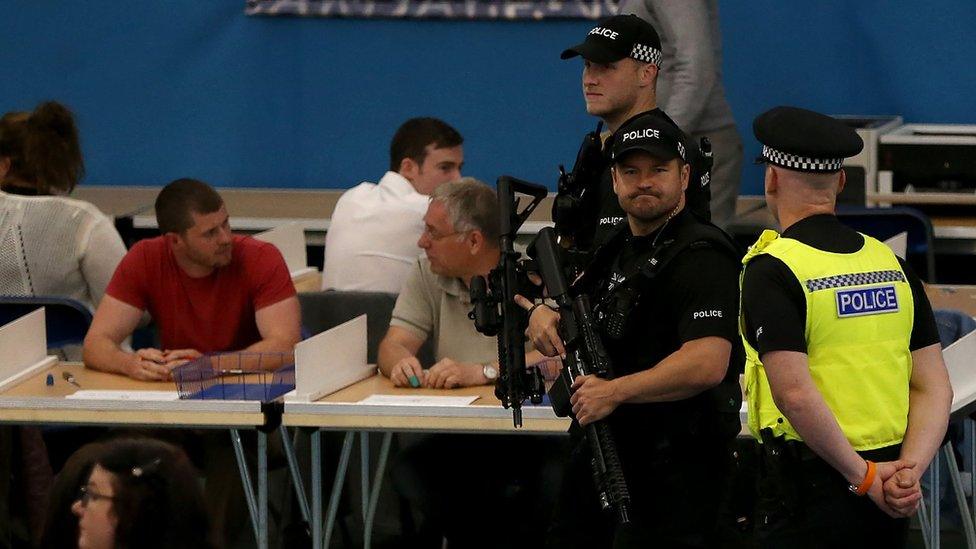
left=96, top=438, right=212, bottom=549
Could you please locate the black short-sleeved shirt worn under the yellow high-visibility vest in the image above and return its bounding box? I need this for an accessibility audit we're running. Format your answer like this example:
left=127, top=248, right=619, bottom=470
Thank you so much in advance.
left=742, top=214, right=939, bottom=357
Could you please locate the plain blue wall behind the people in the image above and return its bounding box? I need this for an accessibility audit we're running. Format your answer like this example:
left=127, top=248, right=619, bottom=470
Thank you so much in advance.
left=0, top=0, right=976, bottom=194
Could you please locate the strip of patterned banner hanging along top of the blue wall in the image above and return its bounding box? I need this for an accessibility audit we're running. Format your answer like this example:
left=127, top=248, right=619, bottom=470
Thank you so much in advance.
left=245, top=0, right=617, bottom=20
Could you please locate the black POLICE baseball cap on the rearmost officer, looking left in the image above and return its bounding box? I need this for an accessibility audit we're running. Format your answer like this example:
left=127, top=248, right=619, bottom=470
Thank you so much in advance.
left=560, top=15, right=661, bottom=67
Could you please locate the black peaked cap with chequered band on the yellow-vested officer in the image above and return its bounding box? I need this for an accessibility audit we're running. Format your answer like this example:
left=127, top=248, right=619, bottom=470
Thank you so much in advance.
left=752, top=107, right=864, bottom=173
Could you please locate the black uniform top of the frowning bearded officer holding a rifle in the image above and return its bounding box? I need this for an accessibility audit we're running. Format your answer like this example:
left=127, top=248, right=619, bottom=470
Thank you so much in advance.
left=584, top=210, right=744, bottom=454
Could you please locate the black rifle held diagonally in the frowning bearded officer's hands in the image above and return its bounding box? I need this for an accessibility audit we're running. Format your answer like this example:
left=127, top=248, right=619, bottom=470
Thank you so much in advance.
left=528, top=227, right=630, bottom=524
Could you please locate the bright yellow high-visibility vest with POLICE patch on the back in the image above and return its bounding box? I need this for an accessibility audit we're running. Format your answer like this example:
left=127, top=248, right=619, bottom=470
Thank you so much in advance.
left=739, top=230, right=915, bottom=450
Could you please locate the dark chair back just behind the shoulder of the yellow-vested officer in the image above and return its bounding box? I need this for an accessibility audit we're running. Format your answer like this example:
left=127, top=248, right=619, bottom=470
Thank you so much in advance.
left=837, top=206, right=935, bottom=284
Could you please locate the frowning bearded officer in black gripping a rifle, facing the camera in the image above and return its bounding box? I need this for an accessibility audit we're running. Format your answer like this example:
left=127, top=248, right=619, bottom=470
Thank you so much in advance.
left=523, top=114, right=741, bottom=548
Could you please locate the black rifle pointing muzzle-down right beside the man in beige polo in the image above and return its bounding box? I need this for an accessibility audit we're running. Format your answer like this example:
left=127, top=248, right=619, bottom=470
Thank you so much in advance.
left=468, top=176, right=548, bottom=427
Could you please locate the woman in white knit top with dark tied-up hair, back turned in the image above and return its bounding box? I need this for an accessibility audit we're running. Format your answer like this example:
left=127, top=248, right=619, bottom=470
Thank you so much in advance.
left=0, top=102, right=125, bottom=310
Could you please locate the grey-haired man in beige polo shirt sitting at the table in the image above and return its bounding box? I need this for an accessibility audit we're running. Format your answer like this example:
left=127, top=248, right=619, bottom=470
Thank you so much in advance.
left=377, top=177, right=543, bottom=389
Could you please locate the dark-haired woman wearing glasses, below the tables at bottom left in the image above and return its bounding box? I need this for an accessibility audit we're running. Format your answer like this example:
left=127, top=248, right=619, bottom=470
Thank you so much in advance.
left=71, top=439, right=212, bottom=549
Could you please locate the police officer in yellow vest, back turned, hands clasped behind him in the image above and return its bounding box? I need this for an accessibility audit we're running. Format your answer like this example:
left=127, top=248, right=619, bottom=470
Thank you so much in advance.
left=740, top=107, right=952, bottom=548
